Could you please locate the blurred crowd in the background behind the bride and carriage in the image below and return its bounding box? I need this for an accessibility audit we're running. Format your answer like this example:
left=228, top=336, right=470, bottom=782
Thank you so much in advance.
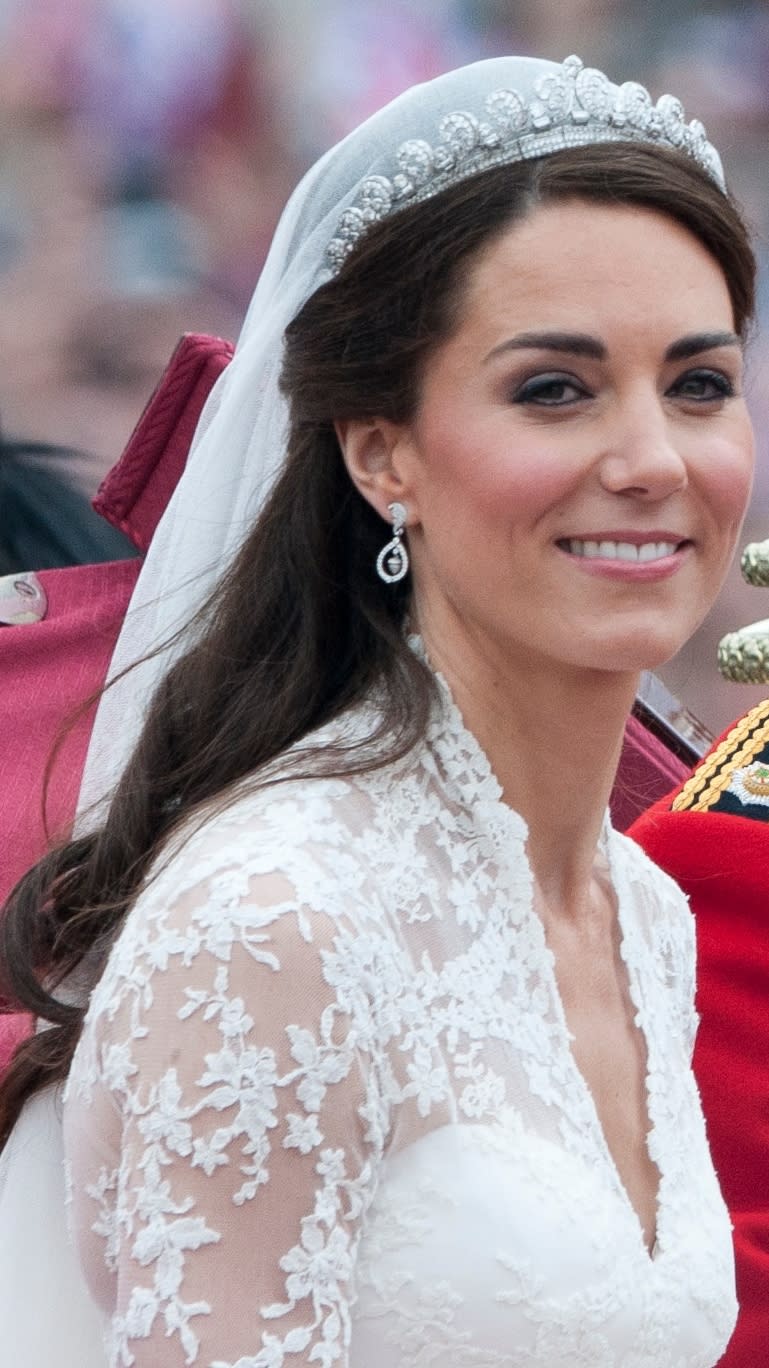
left=0, top=0, right=769, bottom=732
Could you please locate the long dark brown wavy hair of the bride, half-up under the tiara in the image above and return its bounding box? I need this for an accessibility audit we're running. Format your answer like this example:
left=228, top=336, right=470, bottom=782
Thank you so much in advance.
left=0, top=144, right=754, bottom=1144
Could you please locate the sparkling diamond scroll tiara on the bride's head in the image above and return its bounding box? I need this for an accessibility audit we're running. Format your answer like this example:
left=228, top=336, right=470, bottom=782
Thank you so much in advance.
left=327, top=56, right=727, bottom=275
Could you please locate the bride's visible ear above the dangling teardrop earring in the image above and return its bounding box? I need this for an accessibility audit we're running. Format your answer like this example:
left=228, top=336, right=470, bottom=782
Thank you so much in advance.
left=335, top=419, right=416, bottom=524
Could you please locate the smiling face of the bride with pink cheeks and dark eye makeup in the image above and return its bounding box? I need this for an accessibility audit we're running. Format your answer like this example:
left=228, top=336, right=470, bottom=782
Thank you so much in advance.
left=380, top=200, right=753, bottom=670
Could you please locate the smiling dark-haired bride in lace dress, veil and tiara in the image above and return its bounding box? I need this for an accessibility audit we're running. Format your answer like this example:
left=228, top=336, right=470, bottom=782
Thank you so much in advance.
left=0, top=57, right=754, bottom=1368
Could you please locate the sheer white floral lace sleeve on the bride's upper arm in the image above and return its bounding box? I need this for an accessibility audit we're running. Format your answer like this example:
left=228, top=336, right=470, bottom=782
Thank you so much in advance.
left=67, top=842, right=386, bottom=1368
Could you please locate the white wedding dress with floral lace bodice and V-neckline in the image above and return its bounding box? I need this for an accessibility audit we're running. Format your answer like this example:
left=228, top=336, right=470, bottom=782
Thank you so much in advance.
left=52, top=675, right=736, bottom=1368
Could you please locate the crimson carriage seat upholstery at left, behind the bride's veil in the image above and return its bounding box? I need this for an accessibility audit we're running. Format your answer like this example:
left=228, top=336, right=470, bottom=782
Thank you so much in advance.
left=0, top=334, right=233, bottom=1068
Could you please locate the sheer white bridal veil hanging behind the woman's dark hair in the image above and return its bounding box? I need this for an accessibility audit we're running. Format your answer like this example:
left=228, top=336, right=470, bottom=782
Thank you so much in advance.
left=0, top=57, right=727, bottom=1368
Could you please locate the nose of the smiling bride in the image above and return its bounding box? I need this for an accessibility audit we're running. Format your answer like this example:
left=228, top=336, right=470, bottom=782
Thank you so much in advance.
left=601, top=394, right=688, bottom=503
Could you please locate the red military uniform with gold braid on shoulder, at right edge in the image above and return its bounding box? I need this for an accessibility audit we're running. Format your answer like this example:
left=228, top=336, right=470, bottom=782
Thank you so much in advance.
left=629, top=702, right=769, bottom=1368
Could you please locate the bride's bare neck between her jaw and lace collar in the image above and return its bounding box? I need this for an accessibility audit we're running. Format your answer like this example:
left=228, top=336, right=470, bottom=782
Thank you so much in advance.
left=424, top=632, right=638, bottom=915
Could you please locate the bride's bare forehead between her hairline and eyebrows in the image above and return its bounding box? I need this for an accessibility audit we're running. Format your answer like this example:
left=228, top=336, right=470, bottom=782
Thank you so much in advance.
left=454, top=200, right=733, bottom=337
